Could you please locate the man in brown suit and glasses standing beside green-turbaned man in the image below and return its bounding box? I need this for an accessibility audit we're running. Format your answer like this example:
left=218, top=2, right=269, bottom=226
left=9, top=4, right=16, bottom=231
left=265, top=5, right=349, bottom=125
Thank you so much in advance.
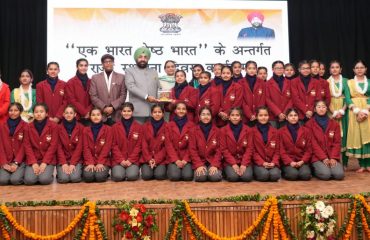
left=89, top=54, right=127, bottom=125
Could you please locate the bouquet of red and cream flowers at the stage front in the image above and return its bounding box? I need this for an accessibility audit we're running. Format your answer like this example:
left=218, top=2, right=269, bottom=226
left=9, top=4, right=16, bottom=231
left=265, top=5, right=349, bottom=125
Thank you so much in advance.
left=113, top=204, right=158, bottom=240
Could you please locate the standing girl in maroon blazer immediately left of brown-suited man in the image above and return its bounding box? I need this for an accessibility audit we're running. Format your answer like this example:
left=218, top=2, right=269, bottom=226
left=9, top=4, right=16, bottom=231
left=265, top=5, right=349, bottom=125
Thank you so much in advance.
left=66, top=58, right=93, bottom=126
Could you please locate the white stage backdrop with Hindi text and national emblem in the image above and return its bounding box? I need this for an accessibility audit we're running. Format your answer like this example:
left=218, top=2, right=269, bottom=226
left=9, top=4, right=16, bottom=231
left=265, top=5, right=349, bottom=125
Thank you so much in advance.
left=47, top=0, right=289, bottom=80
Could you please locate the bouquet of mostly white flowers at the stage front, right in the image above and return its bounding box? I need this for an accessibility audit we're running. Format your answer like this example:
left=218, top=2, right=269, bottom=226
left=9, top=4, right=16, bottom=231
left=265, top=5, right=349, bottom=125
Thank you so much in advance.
left=300, top=201, right=336, bottom=240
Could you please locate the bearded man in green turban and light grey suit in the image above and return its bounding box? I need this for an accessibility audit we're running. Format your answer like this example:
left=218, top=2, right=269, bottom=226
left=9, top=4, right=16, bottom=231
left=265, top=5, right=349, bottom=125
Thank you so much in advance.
left=126, top=47, right=159, bottom=123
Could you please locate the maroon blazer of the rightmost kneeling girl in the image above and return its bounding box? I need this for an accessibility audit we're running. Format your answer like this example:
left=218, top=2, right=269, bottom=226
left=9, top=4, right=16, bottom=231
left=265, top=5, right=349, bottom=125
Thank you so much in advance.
left=306, top=118, right=342, bottom=163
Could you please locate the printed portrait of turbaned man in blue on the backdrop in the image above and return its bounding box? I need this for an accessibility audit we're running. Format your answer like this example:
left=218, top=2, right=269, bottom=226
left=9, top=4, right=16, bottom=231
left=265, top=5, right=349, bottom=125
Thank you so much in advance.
left=238, top=12, right=275, bottom=40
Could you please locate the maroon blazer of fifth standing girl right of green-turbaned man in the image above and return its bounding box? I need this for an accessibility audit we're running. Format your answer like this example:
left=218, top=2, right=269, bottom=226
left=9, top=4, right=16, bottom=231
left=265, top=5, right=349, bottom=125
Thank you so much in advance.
left=266, top=78, right=293, bottom=121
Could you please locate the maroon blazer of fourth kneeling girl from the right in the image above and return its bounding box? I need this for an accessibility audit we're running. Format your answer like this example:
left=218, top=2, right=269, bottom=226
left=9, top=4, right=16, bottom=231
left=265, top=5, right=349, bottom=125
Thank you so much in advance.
left=220, top=124, right=253, bottom=166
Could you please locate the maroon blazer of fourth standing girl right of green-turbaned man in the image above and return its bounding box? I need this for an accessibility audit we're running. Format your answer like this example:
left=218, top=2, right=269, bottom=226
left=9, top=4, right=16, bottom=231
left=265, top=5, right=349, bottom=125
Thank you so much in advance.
left=239, top=78, right=266, bottom=122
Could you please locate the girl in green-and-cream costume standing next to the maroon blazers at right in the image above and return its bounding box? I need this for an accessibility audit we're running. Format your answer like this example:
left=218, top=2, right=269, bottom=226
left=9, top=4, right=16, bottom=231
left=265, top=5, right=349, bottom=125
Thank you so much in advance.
left=327, top=60, right=348, bottom=167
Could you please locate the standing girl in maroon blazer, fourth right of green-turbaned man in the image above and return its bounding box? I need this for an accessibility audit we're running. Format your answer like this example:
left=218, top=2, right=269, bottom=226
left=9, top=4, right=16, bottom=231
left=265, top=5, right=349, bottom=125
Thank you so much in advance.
left=240, top=61, right=266, bottom=127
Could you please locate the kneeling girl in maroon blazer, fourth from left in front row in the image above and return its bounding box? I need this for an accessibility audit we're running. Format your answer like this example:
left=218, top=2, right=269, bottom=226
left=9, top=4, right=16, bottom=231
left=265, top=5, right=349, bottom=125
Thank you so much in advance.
left=82, top=107, right=113, bottom=182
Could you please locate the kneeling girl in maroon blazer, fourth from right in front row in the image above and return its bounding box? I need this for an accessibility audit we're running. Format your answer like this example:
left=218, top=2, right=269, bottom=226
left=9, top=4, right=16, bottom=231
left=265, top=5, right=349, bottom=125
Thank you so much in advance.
left=220, top=108, right=253, bottom=182
